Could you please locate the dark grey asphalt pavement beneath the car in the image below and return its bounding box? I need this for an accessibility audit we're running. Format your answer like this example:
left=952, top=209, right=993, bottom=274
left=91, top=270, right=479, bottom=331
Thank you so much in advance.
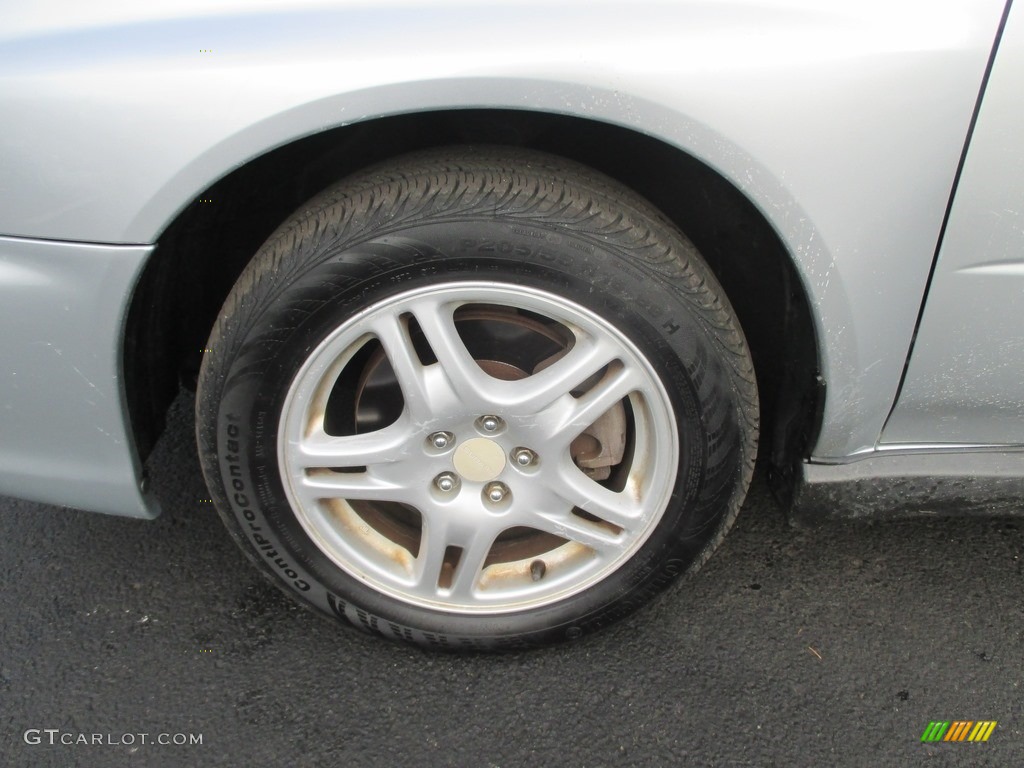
left=0, top=398, right=1024, bottom=768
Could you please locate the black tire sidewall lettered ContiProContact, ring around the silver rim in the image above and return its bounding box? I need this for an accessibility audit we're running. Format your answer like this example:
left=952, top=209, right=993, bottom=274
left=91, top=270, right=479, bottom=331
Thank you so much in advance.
left=201, top=193, right=743, bottom=648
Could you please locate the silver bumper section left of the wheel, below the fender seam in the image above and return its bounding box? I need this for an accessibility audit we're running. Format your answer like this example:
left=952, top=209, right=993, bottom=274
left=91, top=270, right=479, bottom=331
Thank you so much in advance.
left=0, top=238, right=159, bottom=517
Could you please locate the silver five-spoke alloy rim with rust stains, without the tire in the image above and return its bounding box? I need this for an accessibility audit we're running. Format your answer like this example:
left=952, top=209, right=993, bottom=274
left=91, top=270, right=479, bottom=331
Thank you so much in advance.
left=278, top=282, right=679, bottom=612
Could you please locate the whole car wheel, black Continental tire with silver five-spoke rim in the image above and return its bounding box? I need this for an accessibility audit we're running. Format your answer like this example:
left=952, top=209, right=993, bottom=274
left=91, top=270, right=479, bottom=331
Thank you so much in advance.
left=197, top=147, right=758, bottom=648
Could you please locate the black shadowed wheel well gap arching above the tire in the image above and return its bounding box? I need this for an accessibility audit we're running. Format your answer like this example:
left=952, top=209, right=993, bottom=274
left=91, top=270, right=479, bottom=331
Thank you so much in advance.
left=125, top=111, right=821, bottom=489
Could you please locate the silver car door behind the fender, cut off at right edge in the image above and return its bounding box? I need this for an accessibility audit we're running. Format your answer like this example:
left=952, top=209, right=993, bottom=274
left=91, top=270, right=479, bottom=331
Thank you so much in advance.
left=883, top=3, right=1024, bottom=444
